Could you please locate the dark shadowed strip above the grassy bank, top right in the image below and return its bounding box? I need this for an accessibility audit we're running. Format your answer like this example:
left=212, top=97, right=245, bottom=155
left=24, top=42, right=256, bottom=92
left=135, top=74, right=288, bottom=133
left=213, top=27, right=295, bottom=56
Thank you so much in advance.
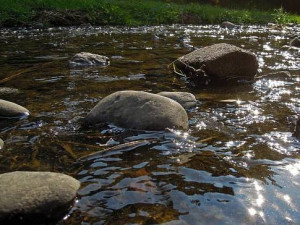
left=166, top=0, right=300, bottom=14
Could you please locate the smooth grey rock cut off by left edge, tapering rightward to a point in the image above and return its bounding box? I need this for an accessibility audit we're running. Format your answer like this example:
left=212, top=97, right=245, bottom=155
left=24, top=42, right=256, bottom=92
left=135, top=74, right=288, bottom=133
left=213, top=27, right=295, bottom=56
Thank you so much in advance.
left=0, top=99, right=29, bottom=117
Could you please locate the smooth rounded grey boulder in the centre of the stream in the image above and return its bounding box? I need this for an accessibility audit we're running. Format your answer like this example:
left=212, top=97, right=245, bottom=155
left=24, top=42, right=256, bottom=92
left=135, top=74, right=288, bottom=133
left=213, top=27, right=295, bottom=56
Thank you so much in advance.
left=84, top=91, right=188, bottom=130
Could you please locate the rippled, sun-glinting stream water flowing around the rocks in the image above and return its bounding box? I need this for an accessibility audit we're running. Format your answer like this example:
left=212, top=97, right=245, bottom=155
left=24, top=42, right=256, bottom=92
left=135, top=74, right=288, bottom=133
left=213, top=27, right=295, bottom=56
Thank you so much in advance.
left=0, top=25, right=300, bottom=225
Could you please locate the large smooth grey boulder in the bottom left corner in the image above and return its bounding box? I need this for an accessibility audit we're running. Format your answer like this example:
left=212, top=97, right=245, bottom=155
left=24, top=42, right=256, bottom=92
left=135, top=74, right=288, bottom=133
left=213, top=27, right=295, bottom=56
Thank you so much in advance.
left=0, top=171, right=80, bottom=224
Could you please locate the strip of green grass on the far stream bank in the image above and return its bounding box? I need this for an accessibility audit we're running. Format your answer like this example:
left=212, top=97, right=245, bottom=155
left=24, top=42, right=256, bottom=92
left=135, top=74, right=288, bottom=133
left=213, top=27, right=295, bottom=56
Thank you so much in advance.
left=0, top=0, right=300, bottom=26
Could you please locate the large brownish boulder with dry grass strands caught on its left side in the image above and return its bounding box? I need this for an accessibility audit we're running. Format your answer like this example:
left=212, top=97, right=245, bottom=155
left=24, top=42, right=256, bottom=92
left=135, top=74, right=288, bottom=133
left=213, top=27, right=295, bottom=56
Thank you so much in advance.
left=174, top=43, right=258, bottom=79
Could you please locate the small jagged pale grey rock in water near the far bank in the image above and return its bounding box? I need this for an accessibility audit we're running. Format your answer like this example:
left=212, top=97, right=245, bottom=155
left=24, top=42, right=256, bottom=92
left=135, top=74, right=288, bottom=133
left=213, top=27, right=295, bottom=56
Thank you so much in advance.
left=69, top=52, right=110, bottom=67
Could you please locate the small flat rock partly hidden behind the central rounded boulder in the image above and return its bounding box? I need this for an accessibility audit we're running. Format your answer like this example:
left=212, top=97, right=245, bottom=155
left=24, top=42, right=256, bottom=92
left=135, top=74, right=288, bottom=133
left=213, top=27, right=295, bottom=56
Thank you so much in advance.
left=157, top=92, right=197, bottom=109
